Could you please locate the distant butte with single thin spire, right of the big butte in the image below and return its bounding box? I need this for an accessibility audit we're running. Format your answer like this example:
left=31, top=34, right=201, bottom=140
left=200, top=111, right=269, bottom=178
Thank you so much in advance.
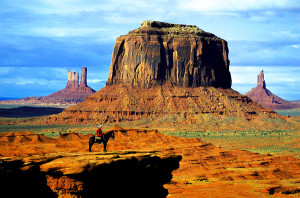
left=245, top=70, right=300, bottom=110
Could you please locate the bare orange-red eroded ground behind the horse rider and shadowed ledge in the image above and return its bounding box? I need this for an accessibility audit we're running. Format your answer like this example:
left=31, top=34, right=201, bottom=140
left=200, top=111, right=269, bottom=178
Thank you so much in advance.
left=0, top=127, right=300, bottom=198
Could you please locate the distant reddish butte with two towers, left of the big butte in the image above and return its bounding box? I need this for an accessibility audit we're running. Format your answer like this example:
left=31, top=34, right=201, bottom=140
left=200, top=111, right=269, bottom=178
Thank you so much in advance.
left=1, top=67, right=96, bottom=105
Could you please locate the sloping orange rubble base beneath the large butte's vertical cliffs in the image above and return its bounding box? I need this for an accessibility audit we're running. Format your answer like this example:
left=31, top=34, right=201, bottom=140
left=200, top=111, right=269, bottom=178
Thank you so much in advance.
left=48, top=85, right=278, bottom=123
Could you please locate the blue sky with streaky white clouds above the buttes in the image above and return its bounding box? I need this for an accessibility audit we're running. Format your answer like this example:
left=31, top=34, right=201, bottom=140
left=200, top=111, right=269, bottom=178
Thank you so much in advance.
left=0, top=0, right=300, bottom=100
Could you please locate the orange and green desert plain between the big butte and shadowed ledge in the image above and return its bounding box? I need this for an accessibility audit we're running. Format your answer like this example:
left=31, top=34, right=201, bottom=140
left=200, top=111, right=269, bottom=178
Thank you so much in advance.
left=0, top=112, right=300, bottom=197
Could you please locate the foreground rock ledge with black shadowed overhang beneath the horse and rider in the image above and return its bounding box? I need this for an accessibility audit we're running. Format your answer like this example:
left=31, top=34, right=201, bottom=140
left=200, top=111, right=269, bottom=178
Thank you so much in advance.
left=0, top=151, right=181, bottom=198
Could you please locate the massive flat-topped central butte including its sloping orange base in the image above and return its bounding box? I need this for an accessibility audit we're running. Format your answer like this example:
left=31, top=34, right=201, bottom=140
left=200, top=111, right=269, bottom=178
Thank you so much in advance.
left=47, top=21, right=280, bottom=123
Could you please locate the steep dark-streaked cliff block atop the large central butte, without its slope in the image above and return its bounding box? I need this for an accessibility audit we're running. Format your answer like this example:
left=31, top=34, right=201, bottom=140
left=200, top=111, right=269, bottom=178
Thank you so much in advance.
left=107, top=21, right=231, bottom=88
